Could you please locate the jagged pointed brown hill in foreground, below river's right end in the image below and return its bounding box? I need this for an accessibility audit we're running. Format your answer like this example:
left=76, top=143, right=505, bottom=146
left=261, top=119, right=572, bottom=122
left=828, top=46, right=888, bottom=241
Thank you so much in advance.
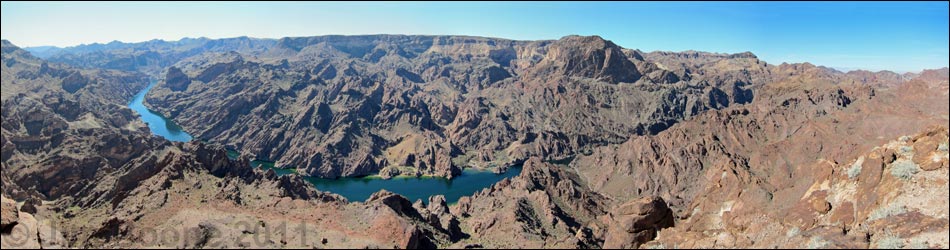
left=450, top=158, right=607, bottom=248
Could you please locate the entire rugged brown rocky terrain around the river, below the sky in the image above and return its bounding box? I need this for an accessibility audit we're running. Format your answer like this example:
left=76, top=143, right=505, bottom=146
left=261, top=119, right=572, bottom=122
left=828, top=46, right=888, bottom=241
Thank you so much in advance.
left=0, top=35, right=950, bottom=249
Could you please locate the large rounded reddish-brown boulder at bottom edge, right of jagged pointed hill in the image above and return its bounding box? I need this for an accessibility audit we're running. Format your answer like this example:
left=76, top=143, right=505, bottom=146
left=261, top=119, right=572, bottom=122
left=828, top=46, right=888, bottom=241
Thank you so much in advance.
left=604, top=197, right=673, bottom=249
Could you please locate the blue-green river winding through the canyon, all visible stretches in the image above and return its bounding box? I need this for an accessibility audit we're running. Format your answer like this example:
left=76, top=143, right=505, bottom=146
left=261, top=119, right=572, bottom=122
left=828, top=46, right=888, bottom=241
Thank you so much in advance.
left=129, top=82, right=521, bottom=203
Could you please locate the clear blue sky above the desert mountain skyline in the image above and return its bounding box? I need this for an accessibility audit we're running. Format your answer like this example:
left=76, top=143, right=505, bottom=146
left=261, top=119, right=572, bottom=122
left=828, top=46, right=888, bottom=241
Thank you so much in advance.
left=0, top=2, right=950, bottom=72
